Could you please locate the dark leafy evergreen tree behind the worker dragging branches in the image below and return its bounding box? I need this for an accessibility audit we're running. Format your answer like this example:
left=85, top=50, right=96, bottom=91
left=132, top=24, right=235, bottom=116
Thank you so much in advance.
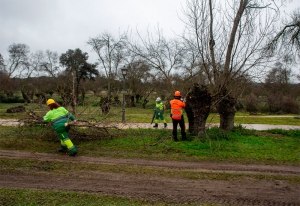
left=60, top=49, right=99, bottom=114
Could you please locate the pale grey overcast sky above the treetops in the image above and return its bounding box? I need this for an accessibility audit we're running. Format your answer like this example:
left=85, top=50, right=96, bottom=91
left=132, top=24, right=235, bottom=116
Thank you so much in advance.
left=0, top=0, right=300, bottom=61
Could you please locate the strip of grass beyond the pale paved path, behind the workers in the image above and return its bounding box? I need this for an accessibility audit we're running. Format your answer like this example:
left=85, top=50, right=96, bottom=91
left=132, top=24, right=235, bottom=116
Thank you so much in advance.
left=0, top=103, right=300, bottom=125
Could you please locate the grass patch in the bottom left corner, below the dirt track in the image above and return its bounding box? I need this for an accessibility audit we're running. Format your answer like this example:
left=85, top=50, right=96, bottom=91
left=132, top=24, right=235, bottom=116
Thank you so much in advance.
left=0, top=188, right=188, bottom=206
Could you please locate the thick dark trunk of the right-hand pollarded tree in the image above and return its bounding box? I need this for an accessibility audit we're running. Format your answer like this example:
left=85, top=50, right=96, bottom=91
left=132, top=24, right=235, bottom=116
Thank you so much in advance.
left=217, top=90, right=236, bottom=131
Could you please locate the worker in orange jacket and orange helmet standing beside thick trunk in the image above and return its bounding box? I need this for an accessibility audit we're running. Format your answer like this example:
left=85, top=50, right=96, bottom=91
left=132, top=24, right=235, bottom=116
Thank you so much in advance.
left=170, top=91, right=186, bottom=141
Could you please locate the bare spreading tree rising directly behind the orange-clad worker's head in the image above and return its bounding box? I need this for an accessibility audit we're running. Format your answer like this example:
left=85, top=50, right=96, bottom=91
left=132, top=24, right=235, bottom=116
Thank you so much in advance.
left=127, top=29, right=191, bottom=94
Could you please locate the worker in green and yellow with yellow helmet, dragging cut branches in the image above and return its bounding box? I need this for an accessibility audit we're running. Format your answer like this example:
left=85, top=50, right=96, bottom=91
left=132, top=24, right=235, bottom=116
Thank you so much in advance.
left=44, top=99, right=78, bottom=156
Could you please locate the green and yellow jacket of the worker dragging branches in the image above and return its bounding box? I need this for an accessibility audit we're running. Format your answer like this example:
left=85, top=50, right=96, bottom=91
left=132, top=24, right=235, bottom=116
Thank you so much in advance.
left=44, top=107, right=75, bottom=130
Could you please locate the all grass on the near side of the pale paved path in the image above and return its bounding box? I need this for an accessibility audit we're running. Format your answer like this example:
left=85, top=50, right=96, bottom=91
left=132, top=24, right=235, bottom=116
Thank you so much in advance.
left=0, top=125, right=300, bottom=206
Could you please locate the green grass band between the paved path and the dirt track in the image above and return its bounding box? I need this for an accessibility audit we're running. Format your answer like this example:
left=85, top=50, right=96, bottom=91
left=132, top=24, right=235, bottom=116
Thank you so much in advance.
left=0, top=126, right=300, bottom=165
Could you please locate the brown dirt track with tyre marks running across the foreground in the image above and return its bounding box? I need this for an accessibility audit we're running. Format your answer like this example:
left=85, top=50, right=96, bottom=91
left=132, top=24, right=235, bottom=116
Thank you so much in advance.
left=0, top=150, right=300, bottom=205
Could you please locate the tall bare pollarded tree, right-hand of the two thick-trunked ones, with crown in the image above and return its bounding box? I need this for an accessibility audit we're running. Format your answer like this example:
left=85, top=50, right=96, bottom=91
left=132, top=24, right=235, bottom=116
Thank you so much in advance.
left=182, top=0, right=278, bottom=130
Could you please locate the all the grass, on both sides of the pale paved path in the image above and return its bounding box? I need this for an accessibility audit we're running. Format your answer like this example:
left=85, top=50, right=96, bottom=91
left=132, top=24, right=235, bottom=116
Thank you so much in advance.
left=0, top=100, right=300, bottom=206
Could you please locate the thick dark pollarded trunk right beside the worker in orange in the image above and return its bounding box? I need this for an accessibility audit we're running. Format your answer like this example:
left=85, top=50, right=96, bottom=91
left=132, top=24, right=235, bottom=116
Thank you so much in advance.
left=185, top=84, right=212, bottom=135
